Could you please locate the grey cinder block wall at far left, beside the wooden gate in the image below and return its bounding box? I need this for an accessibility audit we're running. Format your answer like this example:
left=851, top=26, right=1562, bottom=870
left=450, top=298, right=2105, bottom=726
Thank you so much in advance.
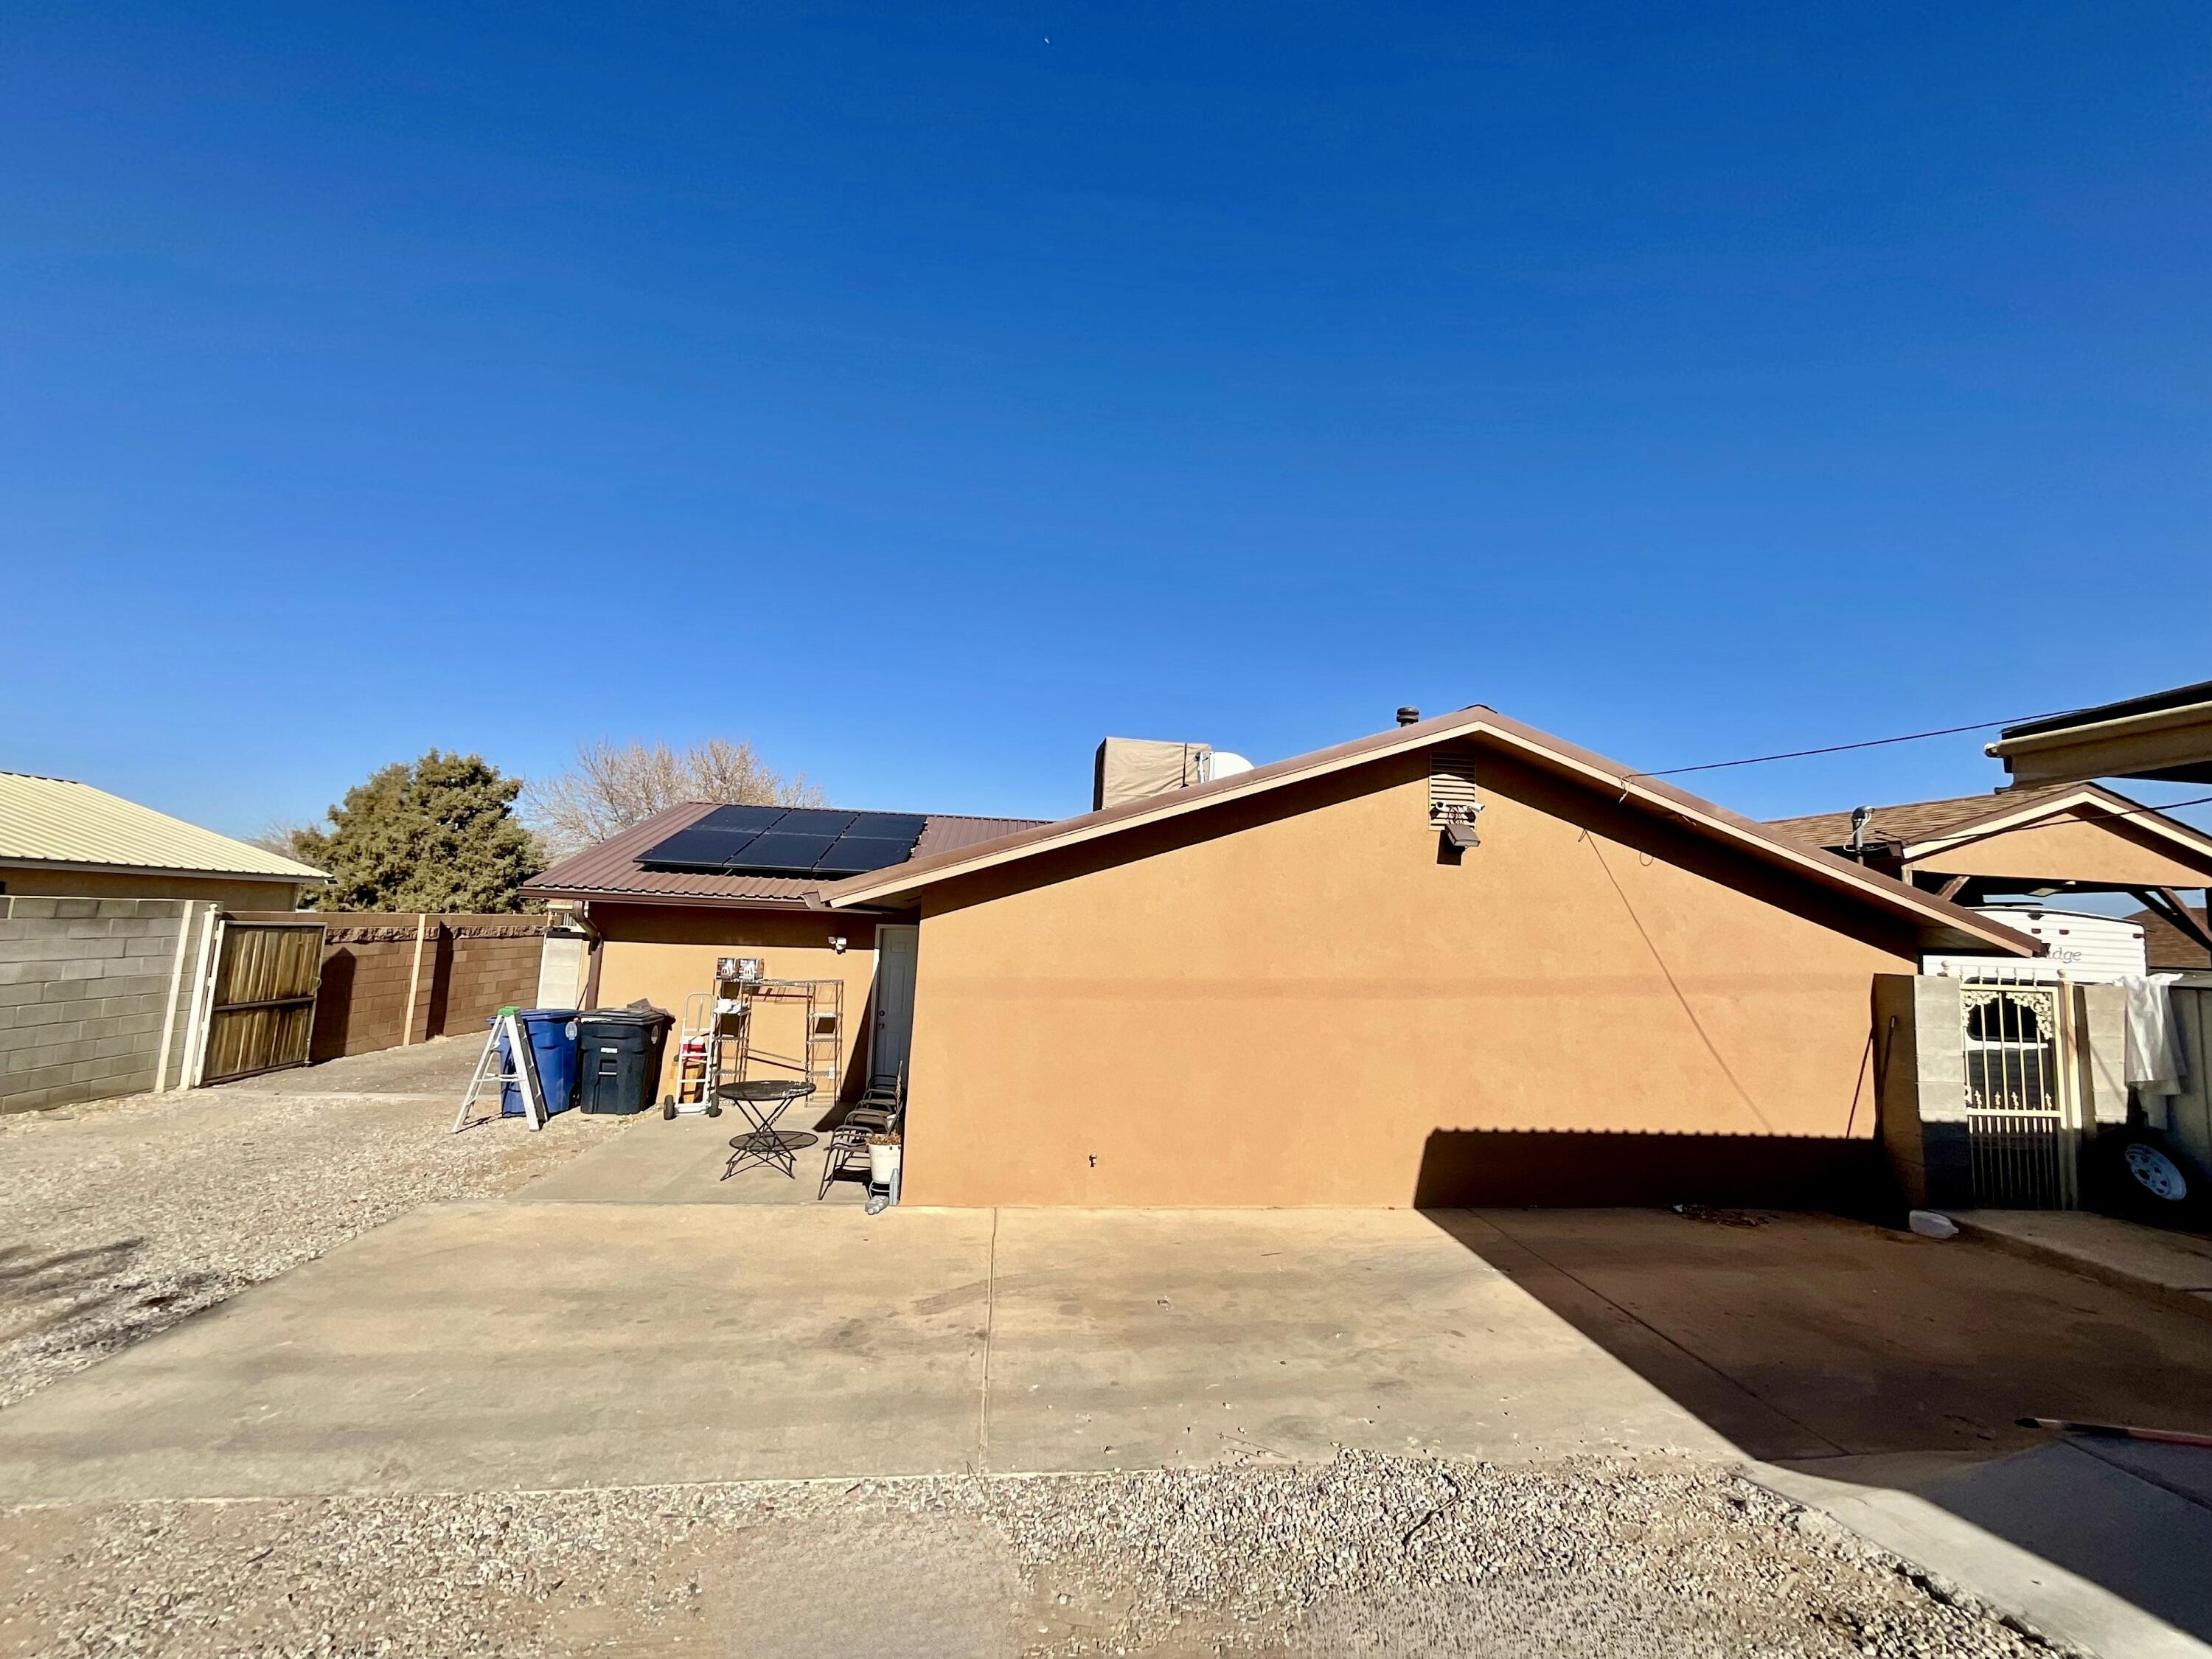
left=0, top=896, right=212, bottom=1113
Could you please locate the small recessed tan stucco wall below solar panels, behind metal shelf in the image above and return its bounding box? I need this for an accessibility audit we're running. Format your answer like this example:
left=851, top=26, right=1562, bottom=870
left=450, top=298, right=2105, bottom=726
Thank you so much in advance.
left=591, top=902, right=894, bottom=1097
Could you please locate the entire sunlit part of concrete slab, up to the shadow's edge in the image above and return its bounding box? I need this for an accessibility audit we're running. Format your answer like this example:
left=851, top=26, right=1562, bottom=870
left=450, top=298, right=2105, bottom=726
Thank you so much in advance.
left=0, top=1212, right=1728, bottom=1500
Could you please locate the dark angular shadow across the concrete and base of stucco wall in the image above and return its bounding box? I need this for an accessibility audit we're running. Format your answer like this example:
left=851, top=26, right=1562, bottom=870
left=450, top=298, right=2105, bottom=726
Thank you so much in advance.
left=1420, top=1130, right=2212, bottom=1639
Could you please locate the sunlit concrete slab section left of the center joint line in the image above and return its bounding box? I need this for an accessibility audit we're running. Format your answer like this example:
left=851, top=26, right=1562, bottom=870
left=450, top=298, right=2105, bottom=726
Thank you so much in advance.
left=0, top=1201, right=991, bottom=1502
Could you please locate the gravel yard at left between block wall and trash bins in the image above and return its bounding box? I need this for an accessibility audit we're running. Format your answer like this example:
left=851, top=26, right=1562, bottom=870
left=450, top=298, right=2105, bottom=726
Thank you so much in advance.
left=0, top=1037, right=624, bottom=1407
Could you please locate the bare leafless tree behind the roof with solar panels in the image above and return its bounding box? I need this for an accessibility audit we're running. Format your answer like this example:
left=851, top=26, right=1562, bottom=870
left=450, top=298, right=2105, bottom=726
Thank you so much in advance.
left=522, top=737, right=823, bottom=858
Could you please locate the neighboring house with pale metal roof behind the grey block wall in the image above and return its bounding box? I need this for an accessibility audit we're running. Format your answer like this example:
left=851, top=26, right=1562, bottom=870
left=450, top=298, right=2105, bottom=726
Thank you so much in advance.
left=0, top=772, right=330, bottom=909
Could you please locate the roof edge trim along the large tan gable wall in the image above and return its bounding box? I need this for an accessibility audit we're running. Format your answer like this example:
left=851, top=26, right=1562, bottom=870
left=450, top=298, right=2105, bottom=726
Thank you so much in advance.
left=823, top=703, right=2042, bottom=956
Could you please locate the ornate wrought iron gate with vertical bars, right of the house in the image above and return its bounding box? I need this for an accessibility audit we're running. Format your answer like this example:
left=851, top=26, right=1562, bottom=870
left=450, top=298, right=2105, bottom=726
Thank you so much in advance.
left=1962, top=980, right=2081, bottom=1210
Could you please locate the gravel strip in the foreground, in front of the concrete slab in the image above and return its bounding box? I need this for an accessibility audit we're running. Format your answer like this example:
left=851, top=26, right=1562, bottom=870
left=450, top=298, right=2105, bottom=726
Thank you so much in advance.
left=0, top=1453, right=2064, bottom=1659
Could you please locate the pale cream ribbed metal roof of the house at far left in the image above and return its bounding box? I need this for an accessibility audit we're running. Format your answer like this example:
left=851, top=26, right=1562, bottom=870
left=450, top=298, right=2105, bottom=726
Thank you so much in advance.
left=0, top=772, right=330, bottom=880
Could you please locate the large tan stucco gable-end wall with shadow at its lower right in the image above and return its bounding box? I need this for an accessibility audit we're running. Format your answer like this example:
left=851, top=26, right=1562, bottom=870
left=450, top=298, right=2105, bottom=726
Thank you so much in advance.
left=905, top=757, right=1913, bottom=1206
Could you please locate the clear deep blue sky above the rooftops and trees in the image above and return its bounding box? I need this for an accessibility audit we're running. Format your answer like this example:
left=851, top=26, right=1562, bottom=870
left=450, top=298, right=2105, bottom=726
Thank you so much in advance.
left=0, top=0, right=2212, bottom=832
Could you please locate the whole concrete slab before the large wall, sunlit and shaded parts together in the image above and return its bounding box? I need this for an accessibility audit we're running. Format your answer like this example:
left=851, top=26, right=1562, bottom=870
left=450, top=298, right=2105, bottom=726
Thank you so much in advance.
left=13, top=1194, right=2212, bottom=1652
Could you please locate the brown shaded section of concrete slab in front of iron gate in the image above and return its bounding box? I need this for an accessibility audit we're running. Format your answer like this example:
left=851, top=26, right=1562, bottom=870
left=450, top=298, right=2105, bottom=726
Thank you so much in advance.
left=1469, top=1210, right=2212, bottom=1460
